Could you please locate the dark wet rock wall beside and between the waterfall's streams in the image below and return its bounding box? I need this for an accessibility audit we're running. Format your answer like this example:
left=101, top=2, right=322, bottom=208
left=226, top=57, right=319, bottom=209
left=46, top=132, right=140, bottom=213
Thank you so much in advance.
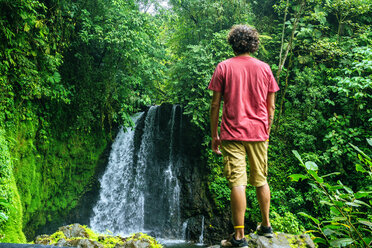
left=143, top=104, right=232, bottom=244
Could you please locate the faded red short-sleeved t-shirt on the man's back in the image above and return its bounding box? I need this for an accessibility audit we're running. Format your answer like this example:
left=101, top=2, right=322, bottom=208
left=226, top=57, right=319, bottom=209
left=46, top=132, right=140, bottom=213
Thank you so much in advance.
left=208, top=56, right=279, bottom=141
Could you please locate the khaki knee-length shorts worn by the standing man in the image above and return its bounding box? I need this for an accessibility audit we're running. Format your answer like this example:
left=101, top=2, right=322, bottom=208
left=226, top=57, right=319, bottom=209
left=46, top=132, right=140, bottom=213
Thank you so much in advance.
left=221, top=140, right=268, bottom=188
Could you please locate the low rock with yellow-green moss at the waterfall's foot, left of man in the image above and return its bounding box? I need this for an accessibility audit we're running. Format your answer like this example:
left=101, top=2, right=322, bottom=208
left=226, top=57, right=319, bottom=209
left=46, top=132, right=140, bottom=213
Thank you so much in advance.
left=35, top=224, right=163, bottom=248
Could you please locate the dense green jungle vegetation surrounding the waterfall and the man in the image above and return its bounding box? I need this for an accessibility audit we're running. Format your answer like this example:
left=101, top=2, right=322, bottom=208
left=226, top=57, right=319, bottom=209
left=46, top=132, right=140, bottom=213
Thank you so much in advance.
left=0, top=0, right=372, bottom=247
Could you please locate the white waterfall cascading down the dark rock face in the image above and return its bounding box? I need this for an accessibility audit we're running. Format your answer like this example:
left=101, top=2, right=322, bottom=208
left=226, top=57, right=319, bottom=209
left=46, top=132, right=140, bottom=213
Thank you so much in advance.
left=90, top=106, right=183, bottom=239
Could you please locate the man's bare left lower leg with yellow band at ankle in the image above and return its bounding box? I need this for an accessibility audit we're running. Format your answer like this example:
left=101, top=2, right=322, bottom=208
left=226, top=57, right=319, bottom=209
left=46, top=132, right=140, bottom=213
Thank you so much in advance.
left=231, top=186, right=247, bottom=240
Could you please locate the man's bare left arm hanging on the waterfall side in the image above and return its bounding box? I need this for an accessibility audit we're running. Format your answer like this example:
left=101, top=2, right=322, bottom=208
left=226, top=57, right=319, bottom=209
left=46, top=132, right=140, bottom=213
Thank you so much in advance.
left=210, top=91, right=222, bottom=154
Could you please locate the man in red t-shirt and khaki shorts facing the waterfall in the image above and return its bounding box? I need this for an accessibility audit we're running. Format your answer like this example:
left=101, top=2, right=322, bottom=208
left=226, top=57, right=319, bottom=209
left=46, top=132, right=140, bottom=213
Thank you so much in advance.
left=208, top=25, right=279, bottom=248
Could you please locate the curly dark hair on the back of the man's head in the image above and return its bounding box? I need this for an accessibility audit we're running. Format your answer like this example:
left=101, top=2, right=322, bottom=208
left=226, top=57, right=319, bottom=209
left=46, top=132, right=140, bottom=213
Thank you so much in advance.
left=227, top=25, right=260, bottom=55
